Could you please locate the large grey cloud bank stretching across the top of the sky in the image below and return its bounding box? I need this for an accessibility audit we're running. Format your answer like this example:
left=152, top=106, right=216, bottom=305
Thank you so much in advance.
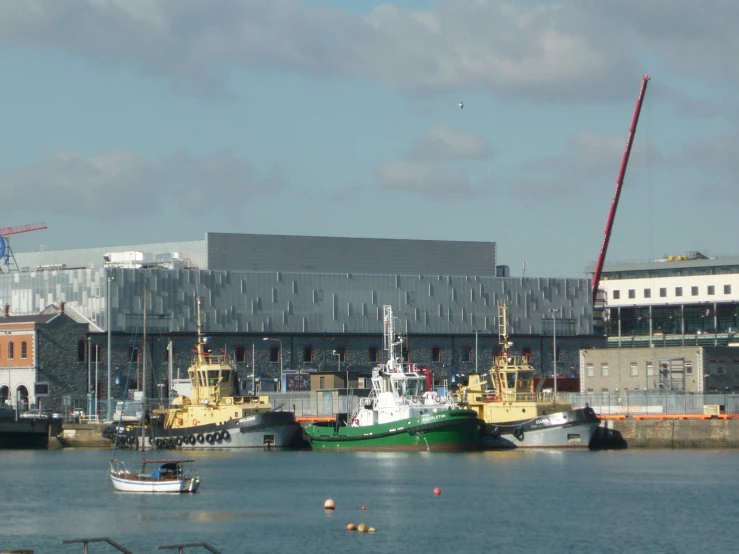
left=0, top=0, right=648, bottom=101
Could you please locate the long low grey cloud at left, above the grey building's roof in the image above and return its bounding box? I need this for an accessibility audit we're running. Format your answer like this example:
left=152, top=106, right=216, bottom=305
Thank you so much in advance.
left=0, top=150, right=286, bottom=219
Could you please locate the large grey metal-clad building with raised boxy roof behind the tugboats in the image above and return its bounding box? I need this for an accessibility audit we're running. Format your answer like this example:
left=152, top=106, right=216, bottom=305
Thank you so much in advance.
left=0, top=233, right=600, bottom=412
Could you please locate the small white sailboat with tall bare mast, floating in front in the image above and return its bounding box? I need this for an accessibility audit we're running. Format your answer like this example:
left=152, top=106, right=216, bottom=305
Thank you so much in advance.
left=109, top=286, right=200, bottom=493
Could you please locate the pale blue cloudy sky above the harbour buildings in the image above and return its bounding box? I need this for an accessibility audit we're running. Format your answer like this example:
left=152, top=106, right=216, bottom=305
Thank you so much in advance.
left=0, top=0, right=739, bottom=278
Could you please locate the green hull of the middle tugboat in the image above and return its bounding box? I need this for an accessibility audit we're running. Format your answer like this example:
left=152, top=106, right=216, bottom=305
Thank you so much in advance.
left=305, top=410, right=481, bottom=451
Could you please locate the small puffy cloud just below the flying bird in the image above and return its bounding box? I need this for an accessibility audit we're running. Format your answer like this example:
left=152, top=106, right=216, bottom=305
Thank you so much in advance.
left=408, top=123, right=491, bottom=160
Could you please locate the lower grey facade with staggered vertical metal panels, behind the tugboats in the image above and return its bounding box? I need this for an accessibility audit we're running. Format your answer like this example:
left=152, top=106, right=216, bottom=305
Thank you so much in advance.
left=0, top=268, right=592, bottom=335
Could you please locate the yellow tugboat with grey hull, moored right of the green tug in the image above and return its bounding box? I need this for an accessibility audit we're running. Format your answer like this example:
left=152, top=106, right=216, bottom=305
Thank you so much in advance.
left=455, top=303, right=600, bottom=448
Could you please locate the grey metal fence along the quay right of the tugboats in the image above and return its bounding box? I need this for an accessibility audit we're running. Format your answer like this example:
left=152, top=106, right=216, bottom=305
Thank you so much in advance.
left=558, top=391, right=739, bottom=415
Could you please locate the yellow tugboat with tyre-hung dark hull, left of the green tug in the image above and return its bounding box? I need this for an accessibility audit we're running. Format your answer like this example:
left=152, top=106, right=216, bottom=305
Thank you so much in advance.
left=110, top=298, right=307, bottom=450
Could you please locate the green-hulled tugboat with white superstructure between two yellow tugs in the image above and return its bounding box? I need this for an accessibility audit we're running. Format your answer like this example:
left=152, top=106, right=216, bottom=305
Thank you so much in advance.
left=305, top=306, right=482, bottom=451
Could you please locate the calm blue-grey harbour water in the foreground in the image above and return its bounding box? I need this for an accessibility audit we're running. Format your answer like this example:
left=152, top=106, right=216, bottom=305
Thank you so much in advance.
left=0, top=450, right=739, bottom=554
